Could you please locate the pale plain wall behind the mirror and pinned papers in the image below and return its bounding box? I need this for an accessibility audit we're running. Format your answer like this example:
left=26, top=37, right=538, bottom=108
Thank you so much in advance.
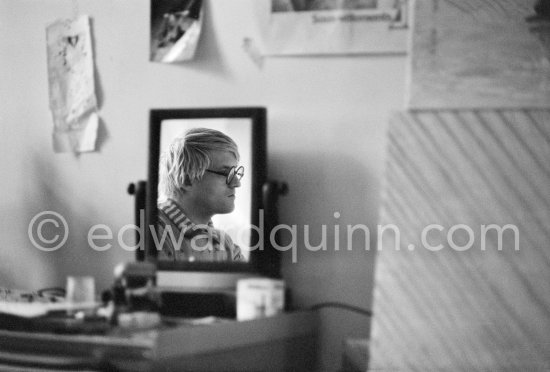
left=0, top=0, right=406, bottom=370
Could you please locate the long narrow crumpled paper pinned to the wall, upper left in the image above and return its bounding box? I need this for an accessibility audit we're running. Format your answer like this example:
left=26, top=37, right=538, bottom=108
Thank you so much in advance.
left=46, top=16, right=99, bottom=153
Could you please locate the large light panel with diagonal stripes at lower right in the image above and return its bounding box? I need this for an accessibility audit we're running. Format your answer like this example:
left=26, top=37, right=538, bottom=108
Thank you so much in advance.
left=370, top=110, right=550, bottom=371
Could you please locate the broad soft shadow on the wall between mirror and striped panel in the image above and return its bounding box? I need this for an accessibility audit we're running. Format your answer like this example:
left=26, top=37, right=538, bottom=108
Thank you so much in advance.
left=270, top=149, right=380, bottom=370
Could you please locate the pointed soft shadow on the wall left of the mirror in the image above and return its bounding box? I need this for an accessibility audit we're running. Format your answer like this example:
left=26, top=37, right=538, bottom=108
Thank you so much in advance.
left=21, top=155, right=133, bottom=291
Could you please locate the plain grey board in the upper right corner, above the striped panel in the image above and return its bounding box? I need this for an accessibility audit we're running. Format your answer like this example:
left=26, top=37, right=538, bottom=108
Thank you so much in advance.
left=407, top=0, right=550, bottom=109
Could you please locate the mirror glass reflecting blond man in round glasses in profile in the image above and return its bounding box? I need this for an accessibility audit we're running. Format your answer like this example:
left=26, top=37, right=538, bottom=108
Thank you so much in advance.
left=157, top=118, right=253, bottom=262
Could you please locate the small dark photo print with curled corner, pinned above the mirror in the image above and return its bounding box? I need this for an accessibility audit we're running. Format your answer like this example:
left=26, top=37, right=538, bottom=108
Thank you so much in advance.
left=150, top=0, right=202, bottom=63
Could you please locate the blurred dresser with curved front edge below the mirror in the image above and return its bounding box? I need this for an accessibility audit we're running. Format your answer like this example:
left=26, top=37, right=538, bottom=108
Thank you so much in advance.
left=0, top=311, right=317, bottom=371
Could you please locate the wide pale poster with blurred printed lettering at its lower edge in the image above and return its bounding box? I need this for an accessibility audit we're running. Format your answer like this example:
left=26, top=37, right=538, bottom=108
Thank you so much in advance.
left=265, top=0, right=410, bottom=56
